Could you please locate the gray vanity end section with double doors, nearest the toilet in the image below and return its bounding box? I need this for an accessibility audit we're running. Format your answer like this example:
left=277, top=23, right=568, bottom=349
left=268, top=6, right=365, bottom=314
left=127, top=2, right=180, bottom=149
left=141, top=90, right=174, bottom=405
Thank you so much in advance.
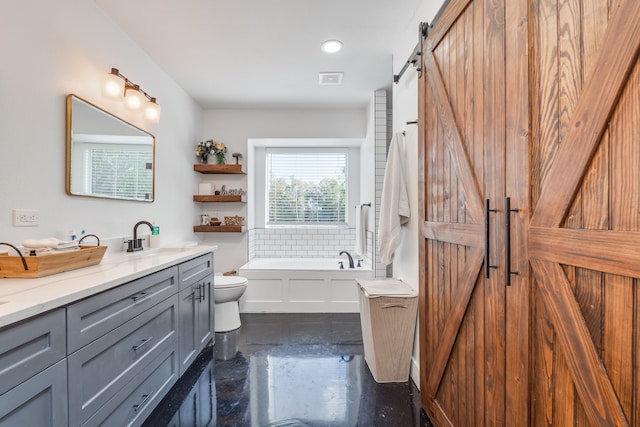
left=178, top=254, right=214, bottom=375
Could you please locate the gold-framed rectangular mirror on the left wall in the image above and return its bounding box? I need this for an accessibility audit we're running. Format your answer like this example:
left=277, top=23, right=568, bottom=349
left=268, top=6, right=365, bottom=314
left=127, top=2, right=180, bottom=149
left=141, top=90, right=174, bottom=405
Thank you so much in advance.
left=66, top=94, right=155, bottom=202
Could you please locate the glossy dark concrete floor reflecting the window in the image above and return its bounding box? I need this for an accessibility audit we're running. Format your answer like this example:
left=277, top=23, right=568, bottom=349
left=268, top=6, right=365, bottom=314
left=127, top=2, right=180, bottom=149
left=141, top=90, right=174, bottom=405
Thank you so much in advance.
left=145, top=314, right=431, bottom=427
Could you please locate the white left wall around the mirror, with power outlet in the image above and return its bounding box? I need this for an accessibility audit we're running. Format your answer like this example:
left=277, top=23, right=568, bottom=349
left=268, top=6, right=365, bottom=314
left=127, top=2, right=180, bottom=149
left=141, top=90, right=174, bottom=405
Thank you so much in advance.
left=0, top=0, right=202, bottom=251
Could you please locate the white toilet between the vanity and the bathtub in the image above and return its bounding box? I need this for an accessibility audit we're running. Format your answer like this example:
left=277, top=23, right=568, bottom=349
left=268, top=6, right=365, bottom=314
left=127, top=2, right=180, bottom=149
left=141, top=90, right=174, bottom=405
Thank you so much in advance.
left=213, top=276, right=248, bottom=332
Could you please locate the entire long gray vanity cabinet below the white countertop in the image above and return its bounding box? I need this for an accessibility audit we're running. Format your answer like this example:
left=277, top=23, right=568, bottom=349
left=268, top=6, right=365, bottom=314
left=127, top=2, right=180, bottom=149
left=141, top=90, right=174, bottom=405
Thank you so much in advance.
left=0, top=249, right=214, bottom=427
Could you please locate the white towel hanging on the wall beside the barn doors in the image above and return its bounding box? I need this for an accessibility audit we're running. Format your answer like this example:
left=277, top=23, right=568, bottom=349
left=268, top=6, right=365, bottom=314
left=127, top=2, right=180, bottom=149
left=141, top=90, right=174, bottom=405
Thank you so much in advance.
left=378, top=132, right=411, bottom=265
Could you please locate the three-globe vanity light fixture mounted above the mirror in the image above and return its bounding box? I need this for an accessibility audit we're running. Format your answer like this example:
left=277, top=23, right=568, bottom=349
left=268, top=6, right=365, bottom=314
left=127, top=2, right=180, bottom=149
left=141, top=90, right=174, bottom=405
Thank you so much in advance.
left=103, top=68, right=160, bottom=123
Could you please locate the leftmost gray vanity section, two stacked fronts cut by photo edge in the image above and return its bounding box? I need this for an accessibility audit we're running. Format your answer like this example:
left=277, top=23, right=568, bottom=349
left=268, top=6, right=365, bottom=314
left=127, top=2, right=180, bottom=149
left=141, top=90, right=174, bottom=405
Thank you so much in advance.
left=0, top=309, right=67, bottom=426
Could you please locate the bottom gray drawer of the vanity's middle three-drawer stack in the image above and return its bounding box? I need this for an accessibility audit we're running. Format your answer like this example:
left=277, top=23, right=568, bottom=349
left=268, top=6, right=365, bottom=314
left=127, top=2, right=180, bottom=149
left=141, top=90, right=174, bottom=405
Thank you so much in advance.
left=83, top=348, right=179, bottom=427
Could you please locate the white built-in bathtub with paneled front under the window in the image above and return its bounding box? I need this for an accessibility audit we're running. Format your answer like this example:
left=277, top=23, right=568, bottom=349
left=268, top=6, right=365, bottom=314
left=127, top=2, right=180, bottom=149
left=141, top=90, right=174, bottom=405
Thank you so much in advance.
left=238, top=257, right=373, bottom=313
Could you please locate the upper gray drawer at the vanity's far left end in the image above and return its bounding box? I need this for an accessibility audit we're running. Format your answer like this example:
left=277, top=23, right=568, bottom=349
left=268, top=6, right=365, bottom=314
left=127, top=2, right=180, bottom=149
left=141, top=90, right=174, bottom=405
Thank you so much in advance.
left=0, top=308, right=67, bottom=394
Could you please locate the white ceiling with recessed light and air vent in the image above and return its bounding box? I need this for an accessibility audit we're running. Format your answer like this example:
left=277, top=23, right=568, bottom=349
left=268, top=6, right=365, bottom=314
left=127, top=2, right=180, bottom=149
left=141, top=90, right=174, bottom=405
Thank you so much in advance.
left=94, top=0, right=428, bottom=109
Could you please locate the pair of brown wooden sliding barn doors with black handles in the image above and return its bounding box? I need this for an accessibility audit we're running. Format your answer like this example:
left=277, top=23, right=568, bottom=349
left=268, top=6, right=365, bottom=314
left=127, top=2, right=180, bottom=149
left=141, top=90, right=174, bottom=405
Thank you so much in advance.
left=420, top=0, right=640, bottom=426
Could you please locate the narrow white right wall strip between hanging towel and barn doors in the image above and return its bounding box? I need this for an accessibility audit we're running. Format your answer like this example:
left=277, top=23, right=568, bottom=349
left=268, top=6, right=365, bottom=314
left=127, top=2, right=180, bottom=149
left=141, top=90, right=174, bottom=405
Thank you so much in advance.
left=393, top=1, right=444, bottom=387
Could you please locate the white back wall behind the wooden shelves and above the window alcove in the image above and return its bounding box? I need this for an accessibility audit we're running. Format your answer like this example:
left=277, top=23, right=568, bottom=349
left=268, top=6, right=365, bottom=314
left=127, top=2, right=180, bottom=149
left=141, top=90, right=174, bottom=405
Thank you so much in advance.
left=198, top=109, right=368, bottom=271
